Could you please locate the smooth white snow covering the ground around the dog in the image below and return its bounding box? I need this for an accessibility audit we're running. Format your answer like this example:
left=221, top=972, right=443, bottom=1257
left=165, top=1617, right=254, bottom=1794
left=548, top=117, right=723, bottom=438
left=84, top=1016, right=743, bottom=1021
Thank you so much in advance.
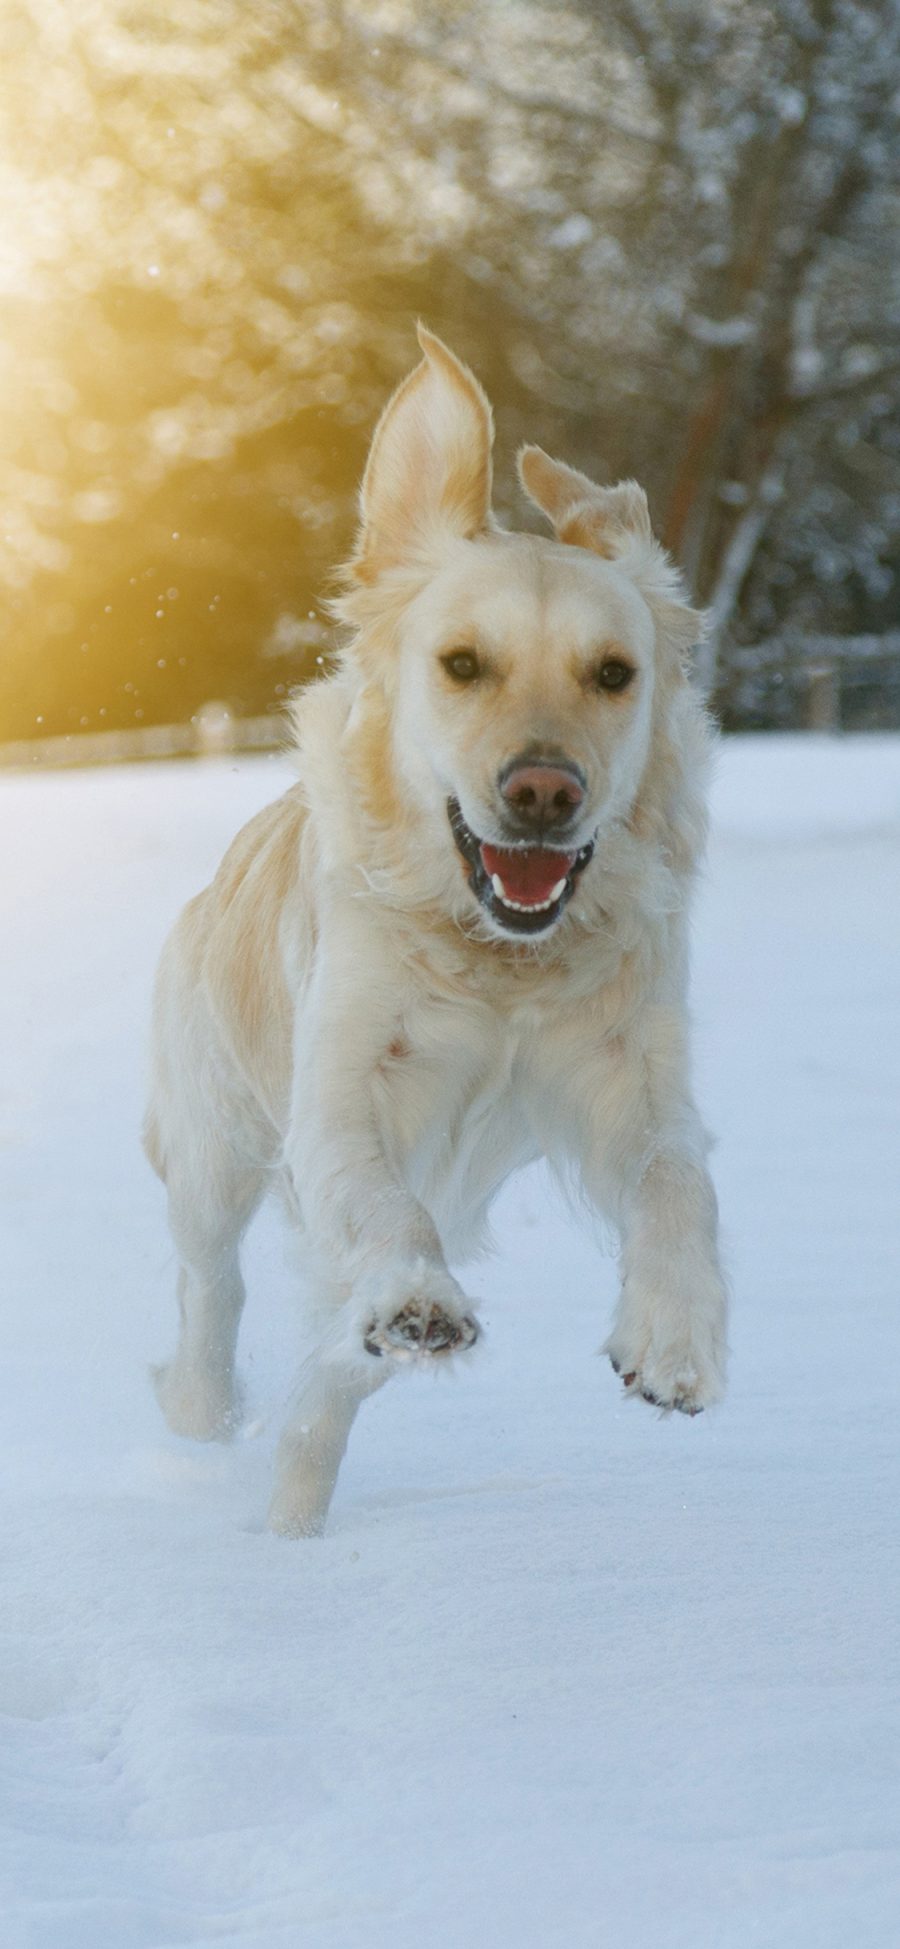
left=0, top=737, right=900, bottom=1949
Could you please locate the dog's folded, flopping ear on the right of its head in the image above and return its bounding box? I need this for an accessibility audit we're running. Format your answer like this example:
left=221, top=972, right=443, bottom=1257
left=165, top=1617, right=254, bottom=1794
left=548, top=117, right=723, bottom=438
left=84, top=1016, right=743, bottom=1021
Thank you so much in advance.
left=518, top=446, right=705, bottom=655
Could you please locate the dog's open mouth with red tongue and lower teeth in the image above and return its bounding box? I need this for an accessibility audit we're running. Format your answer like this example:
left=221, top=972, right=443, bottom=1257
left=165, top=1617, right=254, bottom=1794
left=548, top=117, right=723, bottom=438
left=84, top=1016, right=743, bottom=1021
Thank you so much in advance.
left=446, top=799, right=594, bottom=934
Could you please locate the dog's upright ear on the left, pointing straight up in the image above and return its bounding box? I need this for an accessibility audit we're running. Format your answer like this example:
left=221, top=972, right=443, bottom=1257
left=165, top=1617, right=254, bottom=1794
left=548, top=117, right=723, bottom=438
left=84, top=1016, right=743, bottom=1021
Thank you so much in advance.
left=349, top=325, right=493, bottom=583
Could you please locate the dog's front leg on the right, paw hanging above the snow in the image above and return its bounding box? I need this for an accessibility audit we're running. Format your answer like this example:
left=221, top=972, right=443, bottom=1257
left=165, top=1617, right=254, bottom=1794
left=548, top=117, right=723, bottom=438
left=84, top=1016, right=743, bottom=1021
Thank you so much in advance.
left=568, top=1008, right=727, bottom=1415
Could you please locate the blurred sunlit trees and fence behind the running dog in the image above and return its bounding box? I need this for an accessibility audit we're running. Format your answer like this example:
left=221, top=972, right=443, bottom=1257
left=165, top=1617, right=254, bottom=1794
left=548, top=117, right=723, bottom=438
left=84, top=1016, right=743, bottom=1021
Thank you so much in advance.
left=0, top=0, right=900, bottom=745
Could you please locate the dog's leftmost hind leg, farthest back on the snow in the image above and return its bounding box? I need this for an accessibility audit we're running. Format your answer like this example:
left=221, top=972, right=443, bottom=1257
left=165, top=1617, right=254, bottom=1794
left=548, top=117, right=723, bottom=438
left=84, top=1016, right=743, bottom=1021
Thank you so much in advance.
left=154, top=1134, right=265, bottom=1442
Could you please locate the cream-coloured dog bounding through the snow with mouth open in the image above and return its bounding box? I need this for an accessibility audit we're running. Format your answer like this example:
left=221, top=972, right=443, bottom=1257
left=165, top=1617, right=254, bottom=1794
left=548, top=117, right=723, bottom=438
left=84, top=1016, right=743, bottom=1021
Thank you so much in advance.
left=144, top=329, right=727, bottom=1536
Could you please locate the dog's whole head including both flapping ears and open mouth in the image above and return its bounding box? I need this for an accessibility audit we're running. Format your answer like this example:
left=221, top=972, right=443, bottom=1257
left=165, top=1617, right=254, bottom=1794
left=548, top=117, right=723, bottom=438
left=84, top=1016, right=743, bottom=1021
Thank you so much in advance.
left=333, top=331, right=699, bottom=939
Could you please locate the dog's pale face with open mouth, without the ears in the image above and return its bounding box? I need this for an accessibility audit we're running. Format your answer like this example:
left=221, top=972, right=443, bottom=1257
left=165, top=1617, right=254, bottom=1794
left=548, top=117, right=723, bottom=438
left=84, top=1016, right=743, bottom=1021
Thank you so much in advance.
left=394, top=536, right=655, bottom=937
